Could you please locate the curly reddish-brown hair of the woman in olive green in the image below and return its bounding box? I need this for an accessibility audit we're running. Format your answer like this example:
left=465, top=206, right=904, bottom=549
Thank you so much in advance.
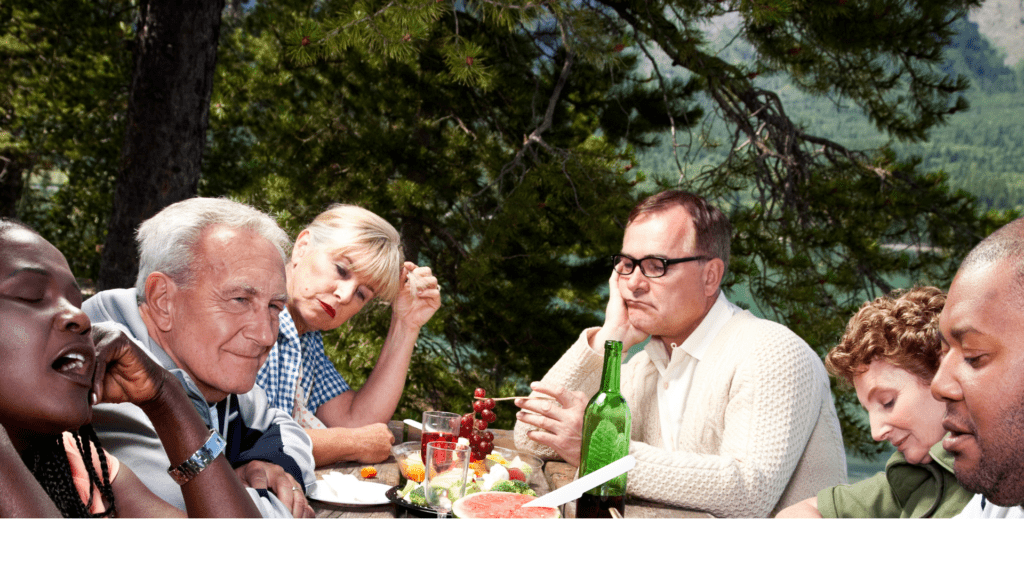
left=825, top=286, right=946, bottom=384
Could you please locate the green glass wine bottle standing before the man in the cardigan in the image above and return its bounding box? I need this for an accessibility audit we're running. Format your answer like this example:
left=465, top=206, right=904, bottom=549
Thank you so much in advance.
left=575, top=340, right=632, bottom=518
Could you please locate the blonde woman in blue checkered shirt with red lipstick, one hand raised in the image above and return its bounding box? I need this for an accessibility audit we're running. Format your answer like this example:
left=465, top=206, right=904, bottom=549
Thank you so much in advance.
left=256, top=205, right=440, bottom=466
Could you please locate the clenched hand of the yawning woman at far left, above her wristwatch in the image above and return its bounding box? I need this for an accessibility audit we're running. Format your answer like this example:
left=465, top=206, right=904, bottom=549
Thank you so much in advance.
left=92, top=324, right=174, bottom=404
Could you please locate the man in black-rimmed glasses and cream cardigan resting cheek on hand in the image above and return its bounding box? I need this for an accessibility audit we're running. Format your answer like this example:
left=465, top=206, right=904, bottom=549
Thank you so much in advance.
left=515, top=191, right=846, bottom=518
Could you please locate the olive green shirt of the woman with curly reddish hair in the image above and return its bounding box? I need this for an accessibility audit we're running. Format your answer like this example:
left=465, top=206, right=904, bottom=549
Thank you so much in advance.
left=818, top=442, right=974, bottom=518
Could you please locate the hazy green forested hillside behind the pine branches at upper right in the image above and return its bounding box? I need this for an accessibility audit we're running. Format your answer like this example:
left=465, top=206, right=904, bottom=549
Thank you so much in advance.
left=638, top=18, right=1024, bottom=209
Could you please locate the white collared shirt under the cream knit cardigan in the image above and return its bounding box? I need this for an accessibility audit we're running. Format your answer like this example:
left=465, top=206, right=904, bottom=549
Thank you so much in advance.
left=644, top=292, right=743, bottom=450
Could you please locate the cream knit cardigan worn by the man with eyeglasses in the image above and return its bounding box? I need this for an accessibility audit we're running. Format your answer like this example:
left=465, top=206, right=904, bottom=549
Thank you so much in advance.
left=515, top=311, right=846, bottom=518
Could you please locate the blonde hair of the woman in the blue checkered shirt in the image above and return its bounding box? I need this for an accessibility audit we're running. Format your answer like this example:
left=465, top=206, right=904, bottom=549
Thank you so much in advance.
left=306, top=204, right=406, bottom=303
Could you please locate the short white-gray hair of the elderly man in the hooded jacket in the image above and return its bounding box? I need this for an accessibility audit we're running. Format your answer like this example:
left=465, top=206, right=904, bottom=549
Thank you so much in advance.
left=135, top=198, right=292, bottom=303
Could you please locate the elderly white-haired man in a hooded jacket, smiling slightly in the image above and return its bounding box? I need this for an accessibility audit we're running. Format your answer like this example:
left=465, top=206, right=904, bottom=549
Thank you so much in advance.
left=82, top=198, right=315, bottom=517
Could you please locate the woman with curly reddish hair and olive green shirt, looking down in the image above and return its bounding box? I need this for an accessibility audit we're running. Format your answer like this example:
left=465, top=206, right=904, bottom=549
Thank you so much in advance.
left=778, top=286, right=973, bottom=518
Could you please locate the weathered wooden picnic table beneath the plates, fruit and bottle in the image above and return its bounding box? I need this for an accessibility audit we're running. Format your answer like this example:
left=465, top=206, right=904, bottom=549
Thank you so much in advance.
left=309, top=421, right=713, bottom=519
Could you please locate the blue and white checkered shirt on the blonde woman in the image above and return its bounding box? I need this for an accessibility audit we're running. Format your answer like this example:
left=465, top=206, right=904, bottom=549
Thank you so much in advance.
left=256, top=308, right=349, bottom=414
